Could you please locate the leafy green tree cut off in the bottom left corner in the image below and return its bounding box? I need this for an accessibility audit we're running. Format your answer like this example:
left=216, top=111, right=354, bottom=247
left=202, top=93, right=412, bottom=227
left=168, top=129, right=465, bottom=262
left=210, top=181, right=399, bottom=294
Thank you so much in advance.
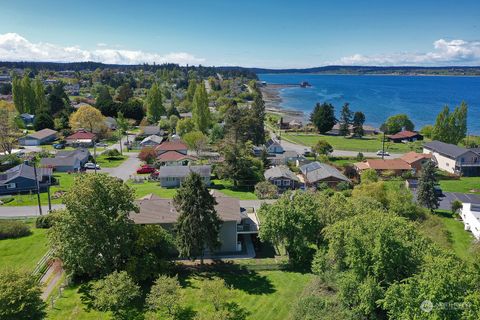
left=0, top=269, right=46, bottom=320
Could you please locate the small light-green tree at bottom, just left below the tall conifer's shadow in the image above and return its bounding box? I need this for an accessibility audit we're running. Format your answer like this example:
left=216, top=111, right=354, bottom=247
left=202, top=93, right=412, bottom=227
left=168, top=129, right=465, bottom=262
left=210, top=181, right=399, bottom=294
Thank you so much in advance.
left=146, top=275, right=181, bottom=318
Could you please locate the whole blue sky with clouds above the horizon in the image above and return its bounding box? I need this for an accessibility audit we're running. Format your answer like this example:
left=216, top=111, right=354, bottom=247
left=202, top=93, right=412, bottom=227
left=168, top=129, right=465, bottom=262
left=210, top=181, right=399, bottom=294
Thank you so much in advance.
left=0, top=0, right=480, bottom=68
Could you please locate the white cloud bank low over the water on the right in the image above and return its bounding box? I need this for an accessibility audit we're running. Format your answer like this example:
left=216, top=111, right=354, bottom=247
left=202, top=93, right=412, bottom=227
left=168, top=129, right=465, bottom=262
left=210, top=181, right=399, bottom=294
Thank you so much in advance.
left=331, top=39, right=480, bottom=66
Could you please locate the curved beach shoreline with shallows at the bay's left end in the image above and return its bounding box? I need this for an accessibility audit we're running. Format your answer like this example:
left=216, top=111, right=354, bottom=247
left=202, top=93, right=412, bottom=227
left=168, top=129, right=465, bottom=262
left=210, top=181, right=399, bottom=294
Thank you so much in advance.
left=260, top=84, right=306, bottom=123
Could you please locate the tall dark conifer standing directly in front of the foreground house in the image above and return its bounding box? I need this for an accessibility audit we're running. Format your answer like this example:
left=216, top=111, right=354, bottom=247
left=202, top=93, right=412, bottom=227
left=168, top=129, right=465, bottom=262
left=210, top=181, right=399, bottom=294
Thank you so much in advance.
left=173, top=173, right=222, bottom=263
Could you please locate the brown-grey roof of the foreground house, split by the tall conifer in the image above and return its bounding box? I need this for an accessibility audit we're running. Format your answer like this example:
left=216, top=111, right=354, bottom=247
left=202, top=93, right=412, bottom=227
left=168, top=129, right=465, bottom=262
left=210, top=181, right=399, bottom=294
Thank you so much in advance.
left=130, top=194, right=241, bottom=224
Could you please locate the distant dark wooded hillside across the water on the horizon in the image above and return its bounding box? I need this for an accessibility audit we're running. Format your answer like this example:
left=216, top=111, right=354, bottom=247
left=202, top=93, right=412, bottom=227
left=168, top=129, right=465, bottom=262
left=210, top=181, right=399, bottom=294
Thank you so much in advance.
left=220, top=66, right=480, bottom=76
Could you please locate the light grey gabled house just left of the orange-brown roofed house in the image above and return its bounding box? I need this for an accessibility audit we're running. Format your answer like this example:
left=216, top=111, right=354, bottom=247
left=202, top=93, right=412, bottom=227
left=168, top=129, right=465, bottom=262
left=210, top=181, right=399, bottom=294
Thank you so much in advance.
left=300, top=161, right=351, bottom=187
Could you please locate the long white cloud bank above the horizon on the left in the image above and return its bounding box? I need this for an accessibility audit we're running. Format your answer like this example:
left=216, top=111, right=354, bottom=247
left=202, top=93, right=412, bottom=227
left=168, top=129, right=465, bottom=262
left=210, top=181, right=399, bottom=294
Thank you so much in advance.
left=0, top=33, right=205, bottom=65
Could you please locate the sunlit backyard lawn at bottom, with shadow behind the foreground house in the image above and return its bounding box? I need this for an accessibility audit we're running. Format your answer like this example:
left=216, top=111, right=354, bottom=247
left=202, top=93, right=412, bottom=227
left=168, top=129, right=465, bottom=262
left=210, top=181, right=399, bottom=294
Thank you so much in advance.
left=47, top=260, right=312, bottom=320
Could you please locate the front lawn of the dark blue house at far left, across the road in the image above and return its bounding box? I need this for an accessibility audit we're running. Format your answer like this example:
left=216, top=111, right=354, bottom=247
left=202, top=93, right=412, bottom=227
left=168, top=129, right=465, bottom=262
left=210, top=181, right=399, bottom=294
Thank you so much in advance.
left=5, top=172, right=76, bottom=206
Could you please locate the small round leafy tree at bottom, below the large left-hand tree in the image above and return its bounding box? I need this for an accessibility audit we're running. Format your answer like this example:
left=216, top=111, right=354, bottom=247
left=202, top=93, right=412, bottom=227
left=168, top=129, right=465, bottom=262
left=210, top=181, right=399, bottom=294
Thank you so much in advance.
left=91, top=271, right=140, bottom=319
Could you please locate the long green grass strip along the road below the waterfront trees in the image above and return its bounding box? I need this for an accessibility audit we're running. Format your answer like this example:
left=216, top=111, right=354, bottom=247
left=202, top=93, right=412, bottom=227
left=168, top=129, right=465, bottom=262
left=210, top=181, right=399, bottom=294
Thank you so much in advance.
left=282, top=133, right=422, bottom=153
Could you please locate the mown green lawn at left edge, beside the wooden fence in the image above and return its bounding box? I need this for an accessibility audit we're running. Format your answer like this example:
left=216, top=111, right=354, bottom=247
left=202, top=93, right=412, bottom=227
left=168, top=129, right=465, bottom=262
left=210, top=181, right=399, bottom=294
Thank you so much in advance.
left=0, top=220, right=48, bottom=271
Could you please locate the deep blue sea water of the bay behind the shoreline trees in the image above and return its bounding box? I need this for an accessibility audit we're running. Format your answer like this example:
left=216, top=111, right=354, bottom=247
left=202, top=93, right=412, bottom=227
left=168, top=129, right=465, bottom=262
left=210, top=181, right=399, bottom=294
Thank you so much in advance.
left=258, top=74, right=480, bottom=135
